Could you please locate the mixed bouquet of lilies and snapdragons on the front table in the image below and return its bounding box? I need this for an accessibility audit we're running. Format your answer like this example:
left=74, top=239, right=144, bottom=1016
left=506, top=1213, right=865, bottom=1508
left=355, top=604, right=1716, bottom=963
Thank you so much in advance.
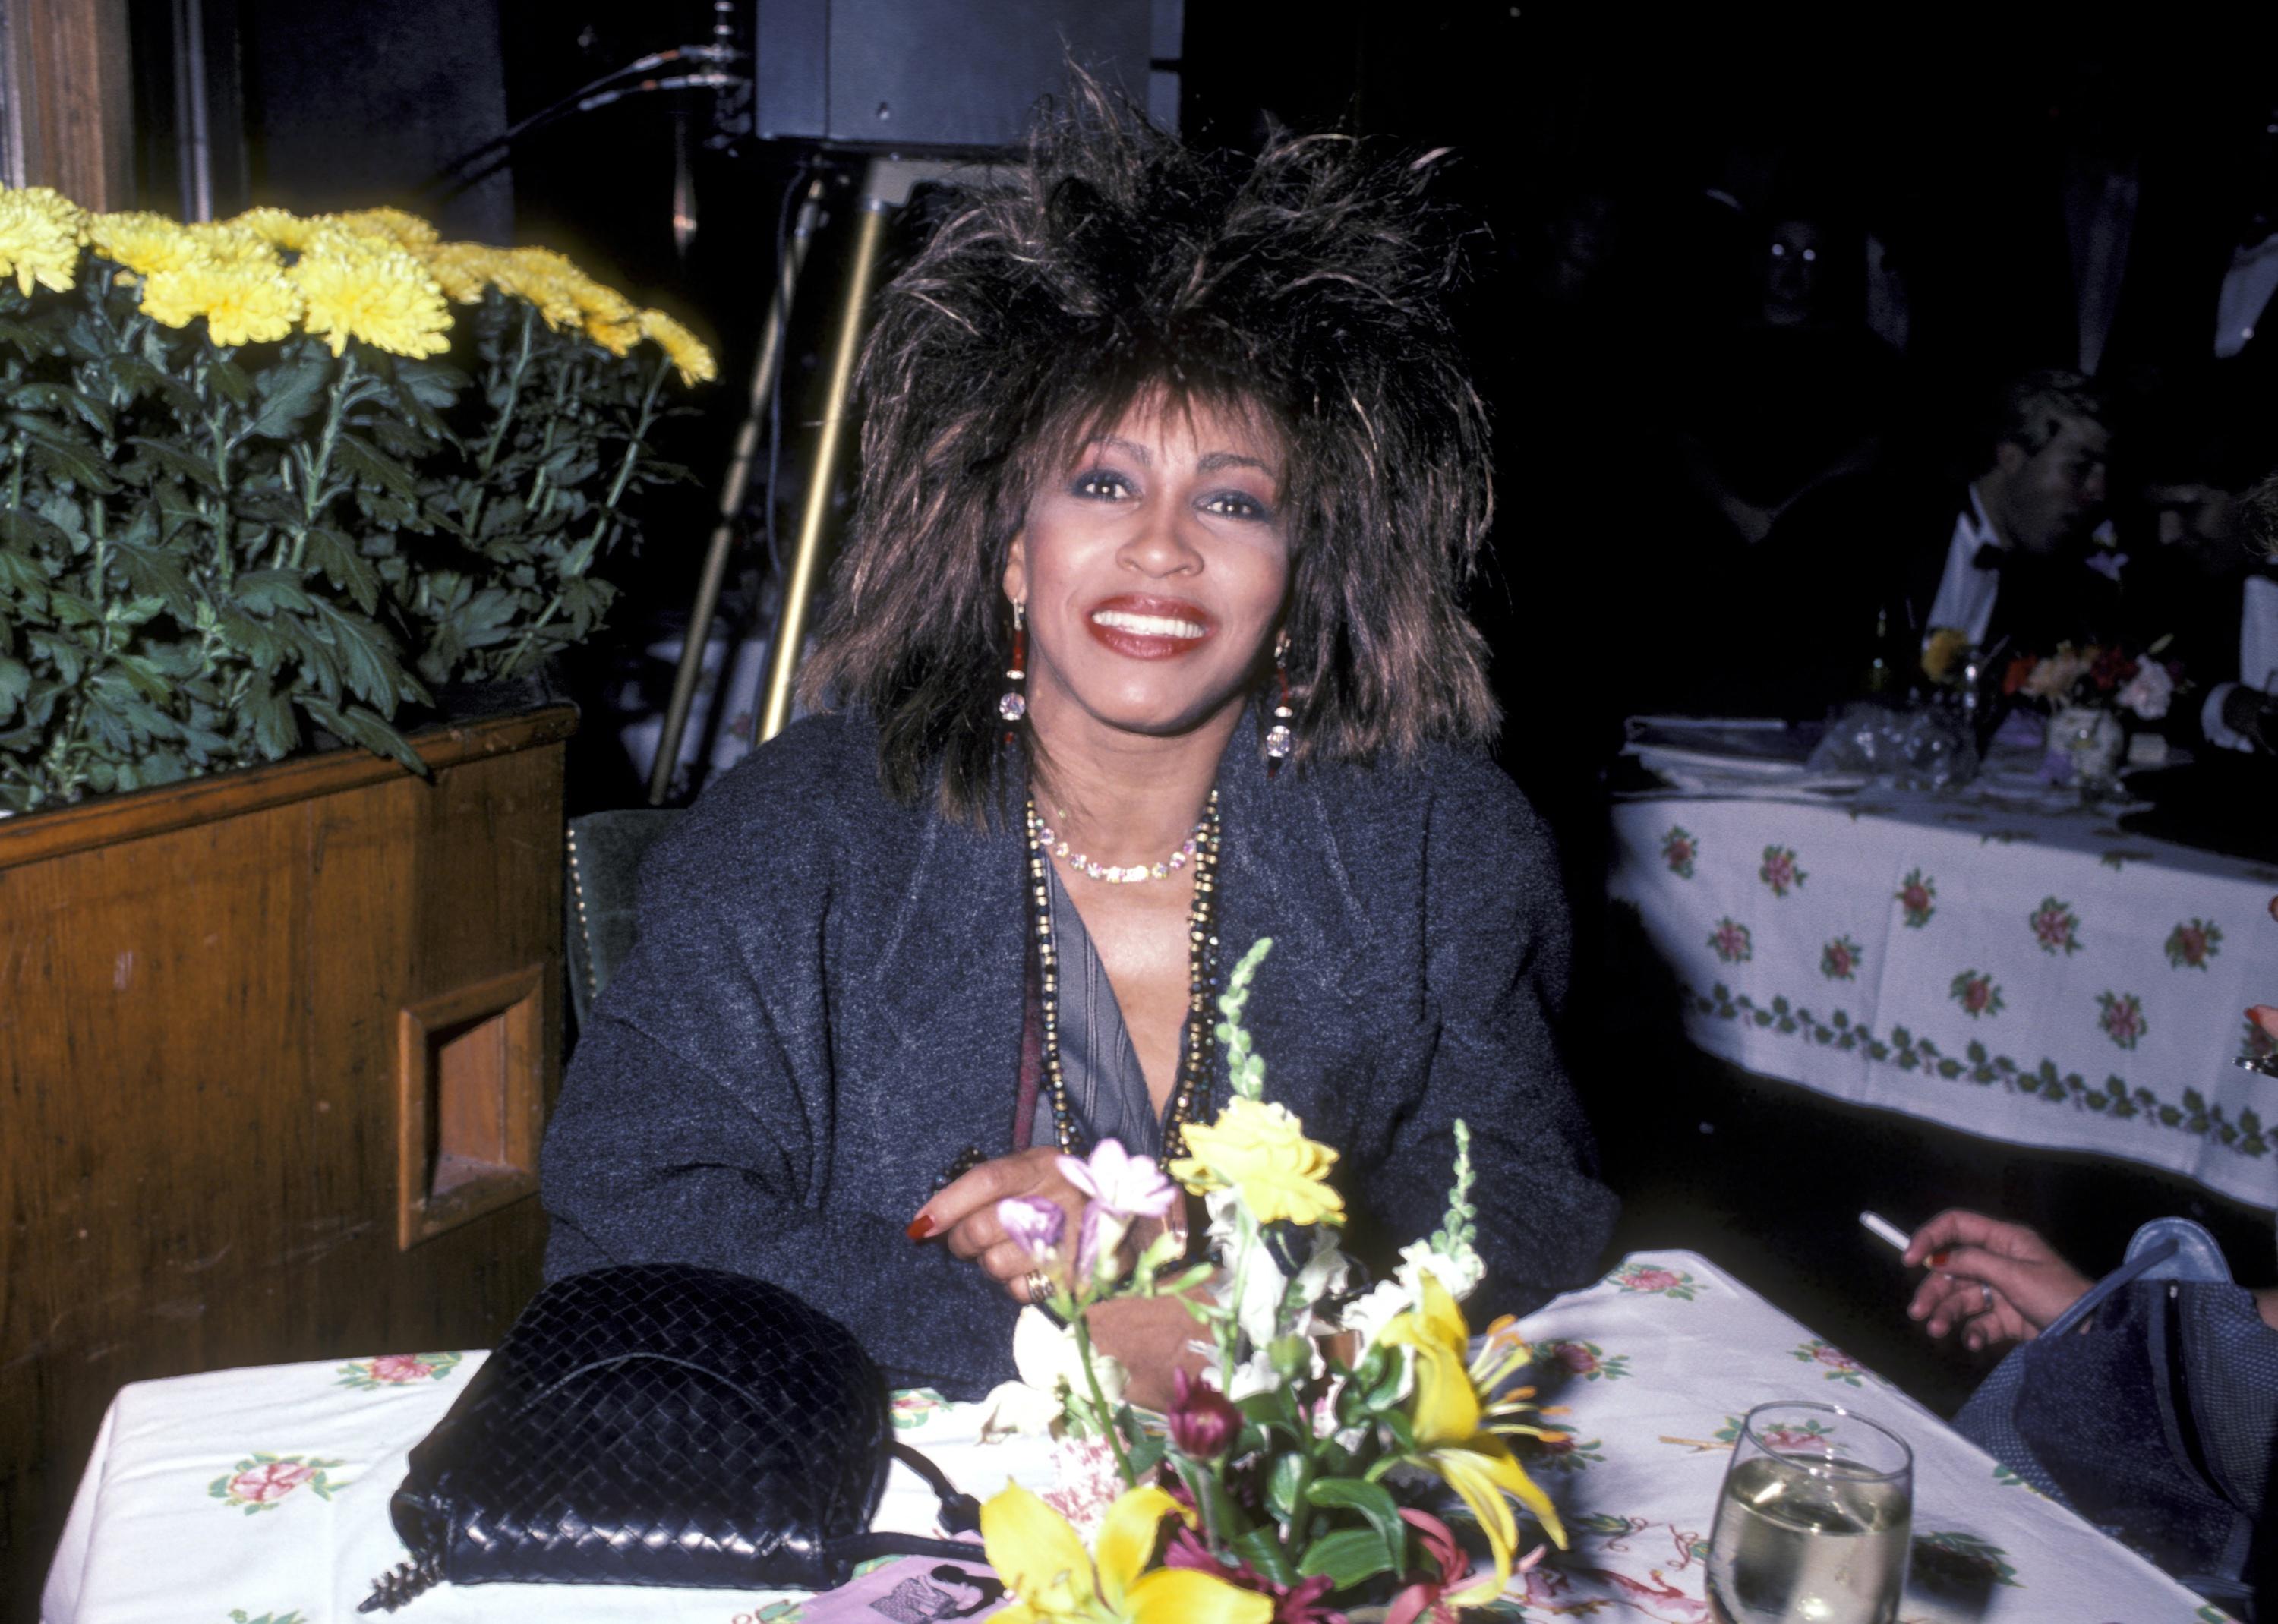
left=982, top=941, right=1565, bottom=1624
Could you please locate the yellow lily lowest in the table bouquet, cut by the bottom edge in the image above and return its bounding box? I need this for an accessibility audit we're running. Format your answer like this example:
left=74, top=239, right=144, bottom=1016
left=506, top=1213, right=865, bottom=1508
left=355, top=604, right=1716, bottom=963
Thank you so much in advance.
left=982, top=1481, right=1273, bottom=1624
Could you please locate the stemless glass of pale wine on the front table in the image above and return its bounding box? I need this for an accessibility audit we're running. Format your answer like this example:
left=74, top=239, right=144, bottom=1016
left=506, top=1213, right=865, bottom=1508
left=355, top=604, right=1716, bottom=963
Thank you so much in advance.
left=1708, top=1399, right=1914, bottom=1624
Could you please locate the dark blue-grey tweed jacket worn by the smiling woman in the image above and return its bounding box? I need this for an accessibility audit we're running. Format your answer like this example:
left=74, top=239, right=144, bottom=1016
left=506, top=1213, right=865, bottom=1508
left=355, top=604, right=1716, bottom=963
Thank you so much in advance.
left=542, top=715, right=1615, bottom=1396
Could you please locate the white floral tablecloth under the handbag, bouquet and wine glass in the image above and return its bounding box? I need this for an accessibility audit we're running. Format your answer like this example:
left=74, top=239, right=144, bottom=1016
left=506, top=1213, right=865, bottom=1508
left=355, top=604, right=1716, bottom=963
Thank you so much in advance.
left=43, top=1253, right=2223, bottom=1624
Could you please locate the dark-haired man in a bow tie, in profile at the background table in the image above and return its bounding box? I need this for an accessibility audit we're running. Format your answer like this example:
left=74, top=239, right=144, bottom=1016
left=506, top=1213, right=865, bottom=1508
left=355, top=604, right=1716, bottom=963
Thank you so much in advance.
left=1907, top=371, right=2119, bottom=654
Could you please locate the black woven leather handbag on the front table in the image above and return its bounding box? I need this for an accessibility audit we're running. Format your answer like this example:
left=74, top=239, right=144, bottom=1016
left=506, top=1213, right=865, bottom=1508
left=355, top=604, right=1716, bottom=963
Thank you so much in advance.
left=360, top=1264, right=977, bottom=1613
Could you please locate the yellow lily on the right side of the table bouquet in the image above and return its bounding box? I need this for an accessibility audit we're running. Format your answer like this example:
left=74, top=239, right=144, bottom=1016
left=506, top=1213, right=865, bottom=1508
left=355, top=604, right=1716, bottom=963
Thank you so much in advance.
left=1378, top=1271, right=1565, bottom=1606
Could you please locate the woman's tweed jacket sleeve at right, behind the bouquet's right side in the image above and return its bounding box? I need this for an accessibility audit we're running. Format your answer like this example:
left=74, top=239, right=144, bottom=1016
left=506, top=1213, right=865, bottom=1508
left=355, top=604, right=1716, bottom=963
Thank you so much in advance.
left=1367, top=758, right=1620, bottom=1328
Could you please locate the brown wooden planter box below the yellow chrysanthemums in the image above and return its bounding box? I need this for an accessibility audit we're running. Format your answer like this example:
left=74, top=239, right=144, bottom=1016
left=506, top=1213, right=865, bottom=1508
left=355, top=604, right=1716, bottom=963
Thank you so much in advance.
left=0, top=706, right=576, bottom=1617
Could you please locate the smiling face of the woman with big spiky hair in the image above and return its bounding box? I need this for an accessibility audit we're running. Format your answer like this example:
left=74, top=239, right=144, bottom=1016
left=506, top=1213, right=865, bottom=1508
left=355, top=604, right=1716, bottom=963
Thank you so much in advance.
left=1005, top=399, right=1289, bottom=738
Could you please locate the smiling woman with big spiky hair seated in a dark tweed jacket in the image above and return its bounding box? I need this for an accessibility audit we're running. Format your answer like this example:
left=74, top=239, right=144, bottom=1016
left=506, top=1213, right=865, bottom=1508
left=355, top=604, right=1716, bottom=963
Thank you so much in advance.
left=544, top=69, right=1613, bottom=1405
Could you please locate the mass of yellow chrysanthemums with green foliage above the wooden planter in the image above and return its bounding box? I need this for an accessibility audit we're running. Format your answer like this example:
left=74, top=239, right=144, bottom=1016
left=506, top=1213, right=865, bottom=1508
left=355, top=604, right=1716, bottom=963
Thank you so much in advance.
left=0, top=187, right=715, bottom=811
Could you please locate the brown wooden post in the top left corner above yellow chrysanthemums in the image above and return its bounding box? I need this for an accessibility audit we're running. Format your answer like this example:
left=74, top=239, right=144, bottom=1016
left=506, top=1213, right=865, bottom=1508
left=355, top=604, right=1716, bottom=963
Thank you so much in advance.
left=0, top=0, right=134, bottom=210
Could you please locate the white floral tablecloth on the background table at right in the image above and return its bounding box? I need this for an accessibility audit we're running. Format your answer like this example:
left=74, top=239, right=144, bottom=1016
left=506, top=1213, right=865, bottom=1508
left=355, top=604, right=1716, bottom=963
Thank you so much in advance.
left=1608, top=795, right=2278, bottom=1207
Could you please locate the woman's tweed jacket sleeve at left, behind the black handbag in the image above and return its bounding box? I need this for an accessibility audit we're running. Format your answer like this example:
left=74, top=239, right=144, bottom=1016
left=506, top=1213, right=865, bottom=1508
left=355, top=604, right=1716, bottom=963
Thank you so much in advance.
left=542, top=770, right=1016, bottom=1399
